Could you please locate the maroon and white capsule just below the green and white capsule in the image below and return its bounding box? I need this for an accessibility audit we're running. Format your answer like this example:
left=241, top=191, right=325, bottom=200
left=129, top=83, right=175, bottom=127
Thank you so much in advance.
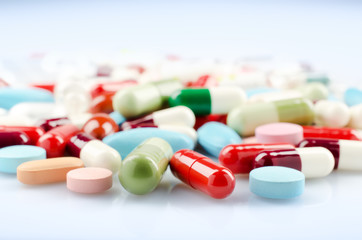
left=121, top=106, right=195, bottom=130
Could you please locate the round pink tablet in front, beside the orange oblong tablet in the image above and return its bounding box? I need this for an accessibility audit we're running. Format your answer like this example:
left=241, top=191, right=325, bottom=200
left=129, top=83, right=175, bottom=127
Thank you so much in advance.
left=67, top=167, right=112, bottom=193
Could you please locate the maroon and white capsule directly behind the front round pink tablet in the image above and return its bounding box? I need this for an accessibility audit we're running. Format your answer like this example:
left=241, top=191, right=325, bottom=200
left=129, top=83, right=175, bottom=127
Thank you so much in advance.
left=67, top=133, right=122, bottom=173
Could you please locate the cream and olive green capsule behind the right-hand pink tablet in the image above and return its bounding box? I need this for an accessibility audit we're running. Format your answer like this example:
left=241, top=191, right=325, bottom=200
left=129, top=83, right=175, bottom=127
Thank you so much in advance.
left=227, top=98, right=314, bottom=137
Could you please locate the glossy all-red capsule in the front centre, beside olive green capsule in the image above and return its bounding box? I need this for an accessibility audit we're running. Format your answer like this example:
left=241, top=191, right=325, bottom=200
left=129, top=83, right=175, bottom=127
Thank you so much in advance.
left=170, top=149, right=235, bottom=199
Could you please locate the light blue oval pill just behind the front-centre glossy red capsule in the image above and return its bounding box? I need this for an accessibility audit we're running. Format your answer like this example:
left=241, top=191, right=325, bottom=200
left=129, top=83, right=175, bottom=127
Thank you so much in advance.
left=197, top=122, right=242, bottom=157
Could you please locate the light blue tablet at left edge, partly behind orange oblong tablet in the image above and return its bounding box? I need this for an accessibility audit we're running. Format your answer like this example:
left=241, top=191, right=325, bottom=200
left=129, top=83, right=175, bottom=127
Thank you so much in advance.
left=0, top=145, right=46, bottom=173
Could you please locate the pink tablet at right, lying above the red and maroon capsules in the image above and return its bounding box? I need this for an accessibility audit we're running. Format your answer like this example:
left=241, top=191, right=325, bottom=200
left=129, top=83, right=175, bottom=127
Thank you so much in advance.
left=255, top=122, right=303, bottom=145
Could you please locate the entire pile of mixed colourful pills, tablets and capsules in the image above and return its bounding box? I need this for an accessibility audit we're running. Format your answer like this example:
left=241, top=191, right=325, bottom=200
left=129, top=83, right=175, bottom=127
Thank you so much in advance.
left=0, top=55, right=362, bottom=199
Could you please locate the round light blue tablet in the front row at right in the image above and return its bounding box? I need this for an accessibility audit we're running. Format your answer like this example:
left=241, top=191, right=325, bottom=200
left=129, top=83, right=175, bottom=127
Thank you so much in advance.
left=249, top=166, right=305, bottom=199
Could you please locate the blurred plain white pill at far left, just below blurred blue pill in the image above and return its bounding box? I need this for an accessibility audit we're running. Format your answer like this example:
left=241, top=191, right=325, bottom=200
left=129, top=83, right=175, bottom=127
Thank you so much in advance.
left=9, top=102, right=66, bottom=123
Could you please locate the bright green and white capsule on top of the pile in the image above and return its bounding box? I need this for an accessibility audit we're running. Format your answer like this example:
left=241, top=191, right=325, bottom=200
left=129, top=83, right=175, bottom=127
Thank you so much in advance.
left=169, top=87, right=246, bottom=116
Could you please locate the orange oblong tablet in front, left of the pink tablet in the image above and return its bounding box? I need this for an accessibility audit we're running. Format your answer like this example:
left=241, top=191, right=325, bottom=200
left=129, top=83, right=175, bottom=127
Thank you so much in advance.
left=17, top=157, right=84, bottom=184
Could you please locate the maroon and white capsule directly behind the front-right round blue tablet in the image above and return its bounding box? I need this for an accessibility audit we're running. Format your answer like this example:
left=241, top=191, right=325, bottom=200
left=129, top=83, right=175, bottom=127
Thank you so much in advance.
left=253, top=147, right=334, bottom=178
